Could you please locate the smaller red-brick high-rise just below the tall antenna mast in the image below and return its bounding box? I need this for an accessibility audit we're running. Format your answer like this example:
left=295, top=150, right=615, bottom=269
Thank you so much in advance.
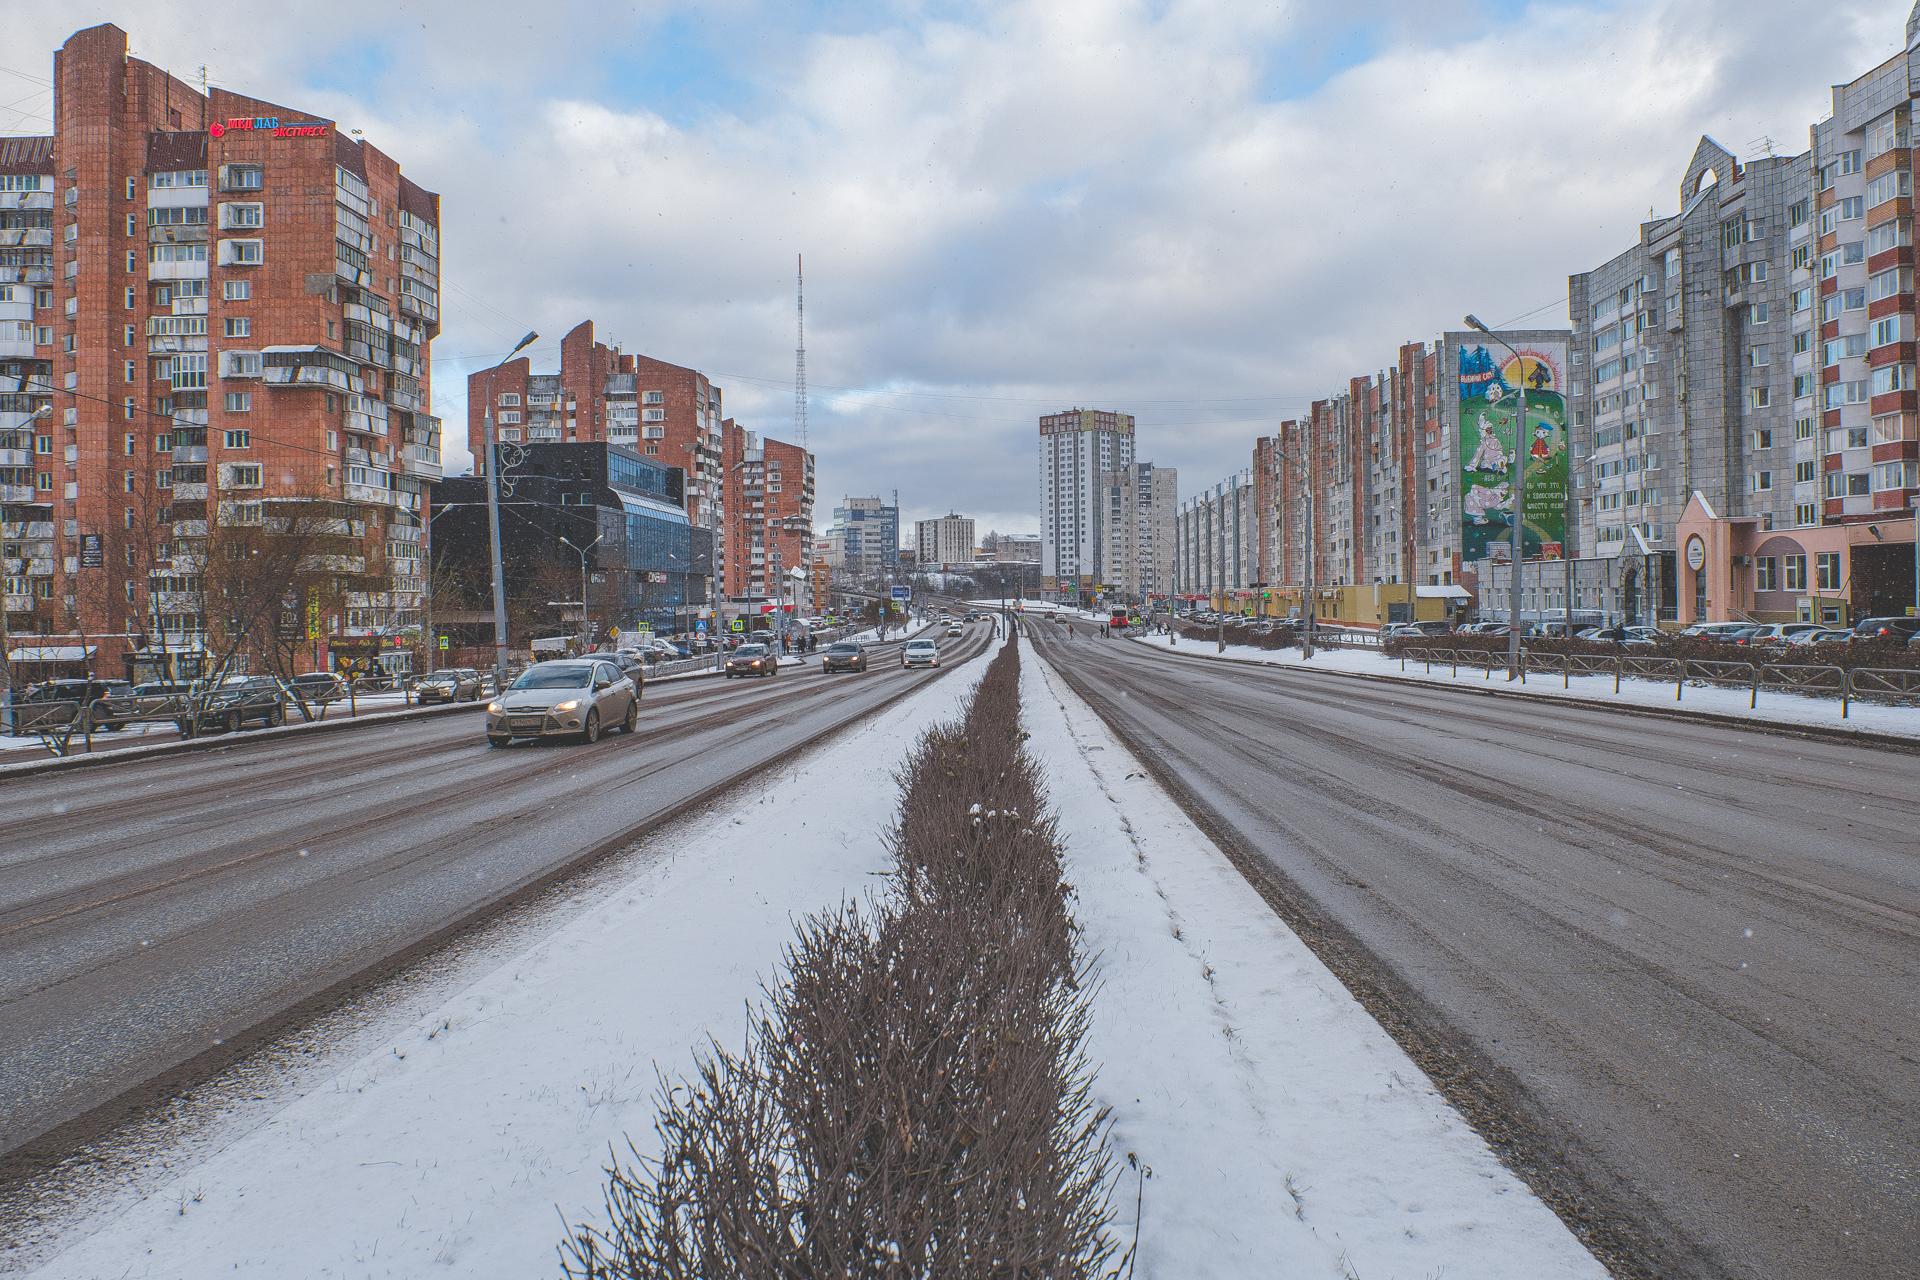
left=720, top=418, right=814, bottom=599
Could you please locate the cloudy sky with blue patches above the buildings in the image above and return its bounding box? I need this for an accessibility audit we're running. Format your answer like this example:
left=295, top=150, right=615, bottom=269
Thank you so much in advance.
left=0, top=0, right=1908, bottom=533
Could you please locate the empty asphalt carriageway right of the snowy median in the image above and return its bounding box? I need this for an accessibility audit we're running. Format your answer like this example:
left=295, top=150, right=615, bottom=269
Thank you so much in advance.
left=1027, top=622, right=1920, bottom=1280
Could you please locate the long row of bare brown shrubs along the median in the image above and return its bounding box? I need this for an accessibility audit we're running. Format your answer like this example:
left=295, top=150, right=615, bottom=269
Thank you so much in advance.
left=561, top=645, right=1117, bottom=1280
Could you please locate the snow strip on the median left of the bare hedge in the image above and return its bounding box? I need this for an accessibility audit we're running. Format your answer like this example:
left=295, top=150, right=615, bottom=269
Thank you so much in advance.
left=31, top=662, right=985, bottom=1280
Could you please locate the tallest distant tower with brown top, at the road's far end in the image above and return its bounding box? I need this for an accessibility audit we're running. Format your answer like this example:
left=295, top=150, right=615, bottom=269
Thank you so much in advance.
left=1041, top=409, right=1133, bottom=601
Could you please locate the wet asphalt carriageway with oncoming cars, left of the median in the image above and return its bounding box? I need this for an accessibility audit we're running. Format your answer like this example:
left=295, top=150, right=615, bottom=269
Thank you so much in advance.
left=0, top=624, right=991, bottom=1159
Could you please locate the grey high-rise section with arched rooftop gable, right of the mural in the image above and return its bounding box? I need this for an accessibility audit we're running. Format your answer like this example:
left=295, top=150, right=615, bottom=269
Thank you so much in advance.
left=1567, top=138, right=1804, bottom=562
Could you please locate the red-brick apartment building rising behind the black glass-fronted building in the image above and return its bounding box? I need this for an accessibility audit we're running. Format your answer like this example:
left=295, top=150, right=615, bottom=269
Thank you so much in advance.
left=467, top=333, right=728, bottom=587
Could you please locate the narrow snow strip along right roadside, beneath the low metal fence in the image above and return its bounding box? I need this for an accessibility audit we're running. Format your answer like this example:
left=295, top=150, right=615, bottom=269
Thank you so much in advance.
left=1129, top=635, right=1920, bottom=737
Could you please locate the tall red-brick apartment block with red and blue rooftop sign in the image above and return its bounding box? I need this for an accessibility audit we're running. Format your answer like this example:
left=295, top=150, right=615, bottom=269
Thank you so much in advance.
left=0, top=25, right=440, bottom=679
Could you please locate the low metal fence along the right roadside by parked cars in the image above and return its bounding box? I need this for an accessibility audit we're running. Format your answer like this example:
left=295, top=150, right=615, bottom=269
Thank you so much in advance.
left=1400, top=645, right=1920, bottom=720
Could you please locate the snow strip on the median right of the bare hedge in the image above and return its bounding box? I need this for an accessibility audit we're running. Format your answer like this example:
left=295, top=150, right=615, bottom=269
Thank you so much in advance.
left=1021, top=651, right=1605, bottom=1280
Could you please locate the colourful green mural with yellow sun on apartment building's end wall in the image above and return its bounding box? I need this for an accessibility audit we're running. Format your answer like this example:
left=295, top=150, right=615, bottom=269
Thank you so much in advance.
left=1457, top=342, right=1567, bottom=560
